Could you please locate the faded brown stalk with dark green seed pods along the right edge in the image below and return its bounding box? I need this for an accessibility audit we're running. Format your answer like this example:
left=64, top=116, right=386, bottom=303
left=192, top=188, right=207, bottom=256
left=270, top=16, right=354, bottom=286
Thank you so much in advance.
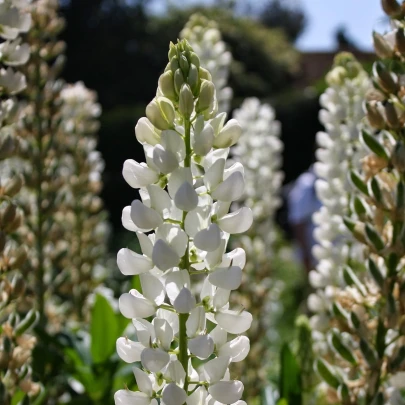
left=317, top=0, right=405, bottom=404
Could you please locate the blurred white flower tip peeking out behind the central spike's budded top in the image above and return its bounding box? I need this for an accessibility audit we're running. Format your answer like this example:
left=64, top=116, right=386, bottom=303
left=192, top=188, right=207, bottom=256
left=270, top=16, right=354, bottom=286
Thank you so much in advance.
left=180, top=14, right=233, bottom=112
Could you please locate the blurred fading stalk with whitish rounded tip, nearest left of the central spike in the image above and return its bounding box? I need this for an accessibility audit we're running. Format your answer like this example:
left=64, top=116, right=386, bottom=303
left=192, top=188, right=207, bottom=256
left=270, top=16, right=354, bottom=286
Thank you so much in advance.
left=60, top=82, right=109, bottom=321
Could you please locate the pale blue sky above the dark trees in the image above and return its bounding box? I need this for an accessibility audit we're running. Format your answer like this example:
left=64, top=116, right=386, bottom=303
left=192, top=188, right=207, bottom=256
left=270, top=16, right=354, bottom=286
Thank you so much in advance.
left=148, top=0, right=386, bottom=50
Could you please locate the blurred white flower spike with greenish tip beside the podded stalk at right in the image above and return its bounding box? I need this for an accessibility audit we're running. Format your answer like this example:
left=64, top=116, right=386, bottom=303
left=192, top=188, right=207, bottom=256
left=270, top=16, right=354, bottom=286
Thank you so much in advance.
left=308, top=53, right=371, bottom=329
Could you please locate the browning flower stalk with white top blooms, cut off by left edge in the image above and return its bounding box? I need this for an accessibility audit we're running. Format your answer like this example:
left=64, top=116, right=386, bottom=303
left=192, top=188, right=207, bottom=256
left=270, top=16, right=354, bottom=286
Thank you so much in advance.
left=0, top=0, right=39, bottom=405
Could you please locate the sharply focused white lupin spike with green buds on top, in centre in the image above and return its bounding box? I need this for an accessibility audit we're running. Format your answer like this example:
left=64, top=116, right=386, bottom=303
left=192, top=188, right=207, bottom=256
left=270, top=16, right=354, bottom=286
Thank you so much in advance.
left=115, top=40, right=252, bottom=405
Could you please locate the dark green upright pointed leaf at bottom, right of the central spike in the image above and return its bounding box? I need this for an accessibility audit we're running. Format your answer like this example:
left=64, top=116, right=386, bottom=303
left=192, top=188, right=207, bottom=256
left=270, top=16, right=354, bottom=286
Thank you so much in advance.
left=279, top=343, right=302, bottom=405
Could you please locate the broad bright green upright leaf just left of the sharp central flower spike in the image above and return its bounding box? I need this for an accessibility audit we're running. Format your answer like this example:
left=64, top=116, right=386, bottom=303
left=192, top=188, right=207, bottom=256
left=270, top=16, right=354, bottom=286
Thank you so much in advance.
left=90, top=294, right=119, bottom=363
